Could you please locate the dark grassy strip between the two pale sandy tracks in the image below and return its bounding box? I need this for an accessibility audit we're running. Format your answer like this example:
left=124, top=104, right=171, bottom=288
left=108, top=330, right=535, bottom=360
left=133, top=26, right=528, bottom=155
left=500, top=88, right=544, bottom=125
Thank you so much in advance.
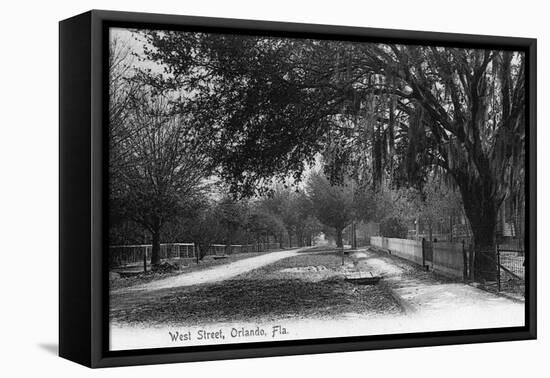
left=110, top=252, right=401, bottom=325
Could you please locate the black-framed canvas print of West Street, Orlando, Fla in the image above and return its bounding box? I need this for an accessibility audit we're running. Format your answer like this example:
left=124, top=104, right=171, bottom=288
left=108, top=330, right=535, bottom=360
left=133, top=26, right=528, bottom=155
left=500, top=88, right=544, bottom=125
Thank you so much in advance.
left=59, top=11, right=536, bottom=367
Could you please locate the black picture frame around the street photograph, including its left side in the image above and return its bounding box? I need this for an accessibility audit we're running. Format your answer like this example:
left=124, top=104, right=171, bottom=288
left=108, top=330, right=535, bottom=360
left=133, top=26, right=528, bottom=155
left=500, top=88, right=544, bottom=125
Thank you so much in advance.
left=59, top=10, right=537, bottom=367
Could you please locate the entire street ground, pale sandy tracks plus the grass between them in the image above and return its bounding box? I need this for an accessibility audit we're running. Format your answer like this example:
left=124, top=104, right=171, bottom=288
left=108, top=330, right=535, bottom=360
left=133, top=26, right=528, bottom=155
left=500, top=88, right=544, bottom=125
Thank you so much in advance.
left=110, top=250, right=525, bottom=350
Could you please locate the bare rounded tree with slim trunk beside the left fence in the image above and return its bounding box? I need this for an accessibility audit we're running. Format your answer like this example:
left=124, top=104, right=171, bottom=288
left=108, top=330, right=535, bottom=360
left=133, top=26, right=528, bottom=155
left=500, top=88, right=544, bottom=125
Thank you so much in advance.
left=111, top=88, right=208, bottom=267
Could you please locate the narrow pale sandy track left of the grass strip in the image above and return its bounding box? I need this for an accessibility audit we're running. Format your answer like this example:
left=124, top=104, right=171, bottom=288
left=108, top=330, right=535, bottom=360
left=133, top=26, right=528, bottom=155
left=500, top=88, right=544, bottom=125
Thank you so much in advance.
left=111, top=248, right=305, bottom=294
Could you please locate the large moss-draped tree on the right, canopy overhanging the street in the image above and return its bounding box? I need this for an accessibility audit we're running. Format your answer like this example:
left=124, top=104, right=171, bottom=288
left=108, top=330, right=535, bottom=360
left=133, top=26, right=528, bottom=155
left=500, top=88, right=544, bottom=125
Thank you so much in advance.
left=138, top=32, right=525, bottom=278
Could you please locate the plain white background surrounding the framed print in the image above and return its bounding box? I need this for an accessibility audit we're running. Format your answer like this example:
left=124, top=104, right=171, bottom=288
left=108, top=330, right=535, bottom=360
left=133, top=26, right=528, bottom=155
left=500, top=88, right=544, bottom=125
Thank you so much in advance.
left=0, top=0, right=550, bottom=378
